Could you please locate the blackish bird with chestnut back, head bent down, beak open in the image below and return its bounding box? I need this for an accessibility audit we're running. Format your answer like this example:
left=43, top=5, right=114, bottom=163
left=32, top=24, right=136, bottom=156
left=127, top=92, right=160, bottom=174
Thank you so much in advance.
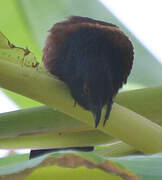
left=43, top=16, right=134, bottom=127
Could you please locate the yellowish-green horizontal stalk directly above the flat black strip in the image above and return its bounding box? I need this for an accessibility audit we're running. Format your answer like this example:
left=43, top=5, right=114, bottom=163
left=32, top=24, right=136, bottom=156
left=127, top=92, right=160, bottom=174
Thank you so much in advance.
left=0, top=129, right=110, bottom=149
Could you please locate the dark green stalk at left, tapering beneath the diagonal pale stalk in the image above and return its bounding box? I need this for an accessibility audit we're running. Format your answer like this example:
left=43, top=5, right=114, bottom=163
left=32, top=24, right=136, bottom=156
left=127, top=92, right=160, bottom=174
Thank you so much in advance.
left=0, top=106, right=90, bottom=139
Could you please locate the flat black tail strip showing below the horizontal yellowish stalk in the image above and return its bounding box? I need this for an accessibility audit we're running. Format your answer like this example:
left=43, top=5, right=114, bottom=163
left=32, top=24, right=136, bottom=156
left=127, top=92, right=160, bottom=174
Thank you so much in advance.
left=29, top=146, right=94, bottom=159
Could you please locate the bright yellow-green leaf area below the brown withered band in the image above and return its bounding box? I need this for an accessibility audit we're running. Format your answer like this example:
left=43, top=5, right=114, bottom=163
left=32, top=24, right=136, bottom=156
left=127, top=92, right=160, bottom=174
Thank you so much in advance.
left=25, top=166, right=124, bottom=180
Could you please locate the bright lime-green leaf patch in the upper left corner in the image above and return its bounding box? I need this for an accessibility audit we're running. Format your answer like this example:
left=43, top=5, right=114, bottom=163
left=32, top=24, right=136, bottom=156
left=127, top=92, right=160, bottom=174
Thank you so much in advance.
left=0, top=0, right=41, bottom=58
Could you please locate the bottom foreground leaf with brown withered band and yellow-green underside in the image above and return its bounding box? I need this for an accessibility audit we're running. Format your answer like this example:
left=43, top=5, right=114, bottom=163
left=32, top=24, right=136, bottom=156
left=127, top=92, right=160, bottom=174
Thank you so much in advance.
left=0, top=152, right=139, bottom=180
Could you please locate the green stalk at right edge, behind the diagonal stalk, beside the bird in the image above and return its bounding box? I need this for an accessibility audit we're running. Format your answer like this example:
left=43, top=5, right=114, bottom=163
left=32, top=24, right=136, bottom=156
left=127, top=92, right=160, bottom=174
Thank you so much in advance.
left=115, top=86, right=162, bottom=125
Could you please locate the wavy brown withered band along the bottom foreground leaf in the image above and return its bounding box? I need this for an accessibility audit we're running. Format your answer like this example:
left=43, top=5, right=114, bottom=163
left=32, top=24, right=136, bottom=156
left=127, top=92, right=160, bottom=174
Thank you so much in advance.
left=0, top=154, right=140, bottom=180
